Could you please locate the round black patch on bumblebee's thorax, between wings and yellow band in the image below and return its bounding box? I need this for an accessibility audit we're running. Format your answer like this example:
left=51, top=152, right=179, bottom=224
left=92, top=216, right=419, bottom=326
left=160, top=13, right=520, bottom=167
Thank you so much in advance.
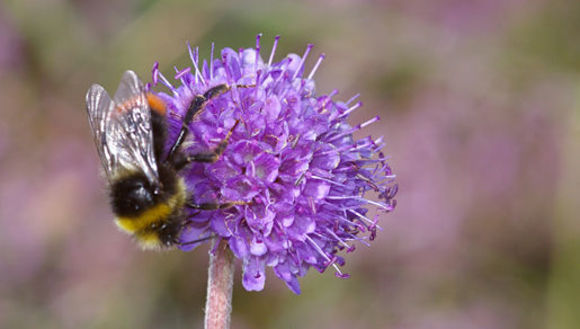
left=111, top=173, right=161, bottom=217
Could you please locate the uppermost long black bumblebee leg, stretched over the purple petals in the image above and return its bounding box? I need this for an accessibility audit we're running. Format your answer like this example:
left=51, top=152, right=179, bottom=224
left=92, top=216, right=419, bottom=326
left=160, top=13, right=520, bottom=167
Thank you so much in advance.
left=167, top=84, right=254, bottom=162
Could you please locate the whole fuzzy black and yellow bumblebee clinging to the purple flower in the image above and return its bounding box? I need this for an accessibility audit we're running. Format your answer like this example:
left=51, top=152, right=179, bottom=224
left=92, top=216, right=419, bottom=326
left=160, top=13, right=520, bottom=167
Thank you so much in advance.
left=86, top=71, right=242, bottom=249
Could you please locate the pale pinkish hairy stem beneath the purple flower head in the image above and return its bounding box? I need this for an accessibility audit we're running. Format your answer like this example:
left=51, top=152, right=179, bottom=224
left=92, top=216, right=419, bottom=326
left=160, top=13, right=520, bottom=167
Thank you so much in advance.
left=205, top=239, right=234, bottom=329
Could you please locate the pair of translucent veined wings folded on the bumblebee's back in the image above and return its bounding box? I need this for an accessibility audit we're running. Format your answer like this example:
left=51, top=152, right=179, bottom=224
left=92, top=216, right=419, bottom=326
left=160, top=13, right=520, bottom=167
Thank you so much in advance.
left=87, top=71, right=159, bottom=183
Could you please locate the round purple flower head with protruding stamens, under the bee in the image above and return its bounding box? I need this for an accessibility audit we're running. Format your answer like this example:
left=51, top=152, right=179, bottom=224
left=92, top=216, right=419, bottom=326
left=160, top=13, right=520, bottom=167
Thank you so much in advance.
left=153, top=36, right=397, bottom=294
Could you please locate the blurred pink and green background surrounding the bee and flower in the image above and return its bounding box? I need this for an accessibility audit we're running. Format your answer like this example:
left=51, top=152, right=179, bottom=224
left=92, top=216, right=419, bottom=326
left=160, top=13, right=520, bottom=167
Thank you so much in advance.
left=0, top=0, right=580, bottom=329
